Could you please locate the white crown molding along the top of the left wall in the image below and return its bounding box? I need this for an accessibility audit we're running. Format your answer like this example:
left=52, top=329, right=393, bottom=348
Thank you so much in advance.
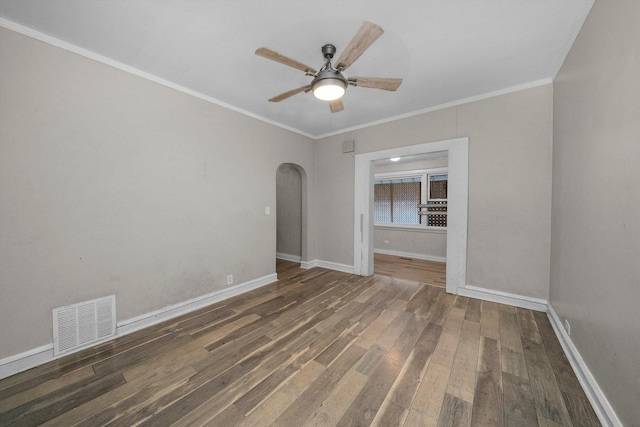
left=0, top=18, right=317, bottom=139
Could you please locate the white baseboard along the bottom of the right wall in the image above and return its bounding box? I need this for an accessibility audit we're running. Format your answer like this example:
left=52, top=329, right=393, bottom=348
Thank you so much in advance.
left=547, top=302, right=622, bottom=427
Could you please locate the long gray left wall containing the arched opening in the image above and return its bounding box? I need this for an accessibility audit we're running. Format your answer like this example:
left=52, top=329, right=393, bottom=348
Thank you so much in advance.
left=0, top=29, right=316, bottom=358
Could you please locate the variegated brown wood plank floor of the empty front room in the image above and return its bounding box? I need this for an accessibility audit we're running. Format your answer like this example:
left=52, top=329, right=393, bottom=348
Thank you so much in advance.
left=0, top=261, right=600, bottom=427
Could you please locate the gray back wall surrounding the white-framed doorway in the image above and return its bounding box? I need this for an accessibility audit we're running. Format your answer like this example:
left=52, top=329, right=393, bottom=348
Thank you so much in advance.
left=316, top=84, right=553, bottom=299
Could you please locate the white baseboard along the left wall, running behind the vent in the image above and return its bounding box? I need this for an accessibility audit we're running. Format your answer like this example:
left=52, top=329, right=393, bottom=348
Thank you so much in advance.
left=0, top=273, right=278, bottom=379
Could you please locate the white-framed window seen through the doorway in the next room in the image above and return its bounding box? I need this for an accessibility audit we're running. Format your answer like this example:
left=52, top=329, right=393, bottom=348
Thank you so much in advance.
left=373, top=169, right=448, bottom=228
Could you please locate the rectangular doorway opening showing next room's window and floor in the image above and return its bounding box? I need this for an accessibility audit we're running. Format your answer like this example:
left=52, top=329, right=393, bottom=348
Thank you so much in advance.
left=373, top=152, right=448, bottom=288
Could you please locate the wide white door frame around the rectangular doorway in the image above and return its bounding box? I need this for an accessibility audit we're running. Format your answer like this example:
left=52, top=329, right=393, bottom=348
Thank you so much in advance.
left=353, top=137, right=469, bottom=294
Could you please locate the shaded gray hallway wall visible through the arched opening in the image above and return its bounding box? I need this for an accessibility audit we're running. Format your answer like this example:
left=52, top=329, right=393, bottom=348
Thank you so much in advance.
left=276, top=164, right=302, bottom=256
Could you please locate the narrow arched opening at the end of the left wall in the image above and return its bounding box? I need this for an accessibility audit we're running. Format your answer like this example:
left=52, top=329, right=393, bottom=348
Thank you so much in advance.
left=276, top=163, right=307, bottom=263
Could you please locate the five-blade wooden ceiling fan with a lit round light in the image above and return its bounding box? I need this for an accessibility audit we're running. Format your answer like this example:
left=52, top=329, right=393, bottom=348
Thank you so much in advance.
left=256, top=21, right=402, bottom=113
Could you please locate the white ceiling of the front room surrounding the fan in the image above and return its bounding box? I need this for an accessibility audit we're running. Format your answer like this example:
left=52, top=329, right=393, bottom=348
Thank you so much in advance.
left=0, top=0, right=593, bottom=138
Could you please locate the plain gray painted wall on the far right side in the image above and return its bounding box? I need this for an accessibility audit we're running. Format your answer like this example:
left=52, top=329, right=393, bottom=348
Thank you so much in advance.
left=550, top=1, right=640, bottom=426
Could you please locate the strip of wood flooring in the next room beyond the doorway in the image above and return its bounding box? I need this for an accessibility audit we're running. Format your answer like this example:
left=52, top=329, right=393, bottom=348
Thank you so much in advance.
left=373, top=254, right=447, bottom=288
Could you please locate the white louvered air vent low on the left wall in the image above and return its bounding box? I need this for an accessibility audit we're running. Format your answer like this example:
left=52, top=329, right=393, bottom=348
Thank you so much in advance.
left=53, top=295, right=116, bottom=354
